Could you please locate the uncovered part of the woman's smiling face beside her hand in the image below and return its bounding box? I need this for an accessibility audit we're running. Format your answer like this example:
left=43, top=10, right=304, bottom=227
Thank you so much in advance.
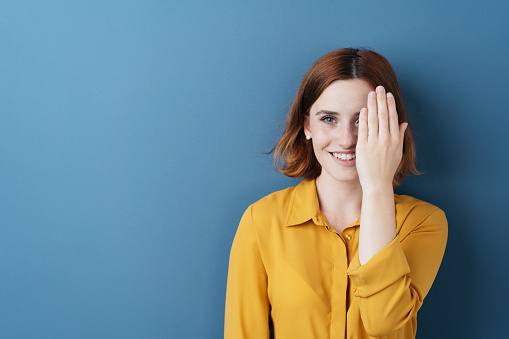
left=304, top=79, right=374, bottom=186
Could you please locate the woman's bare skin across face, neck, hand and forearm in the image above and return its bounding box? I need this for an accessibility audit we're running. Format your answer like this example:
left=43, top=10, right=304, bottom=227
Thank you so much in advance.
left=304, top=79, right=408, bottom=265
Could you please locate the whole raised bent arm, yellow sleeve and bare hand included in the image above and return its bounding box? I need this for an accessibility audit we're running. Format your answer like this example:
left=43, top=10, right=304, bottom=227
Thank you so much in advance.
left=348, top=87, right=447, bottom=336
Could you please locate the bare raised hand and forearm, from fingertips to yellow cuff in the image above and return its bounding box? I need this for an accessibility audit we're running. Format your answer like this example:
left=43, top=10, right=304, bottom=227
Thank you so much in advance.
left=356, top=86, right=408, bottom=264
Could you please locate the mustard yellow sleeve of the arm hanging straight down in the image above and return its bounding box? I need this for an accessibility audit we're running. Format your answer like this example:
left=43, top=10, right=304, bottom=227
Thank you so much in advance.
left=224, top=207, right=270, bottom=339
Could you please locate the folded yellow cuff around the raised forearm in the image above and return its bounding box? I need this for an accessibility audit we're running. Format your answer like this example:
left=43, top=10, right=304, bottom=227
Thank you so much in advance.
left=347, top=237, right=410, bottom=298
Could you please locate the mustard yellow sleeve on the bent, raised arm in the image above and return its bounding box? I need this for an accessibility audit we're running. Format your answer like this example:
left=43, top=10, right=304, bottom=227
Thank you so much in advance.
left=347, top=205, right=447, bottom=337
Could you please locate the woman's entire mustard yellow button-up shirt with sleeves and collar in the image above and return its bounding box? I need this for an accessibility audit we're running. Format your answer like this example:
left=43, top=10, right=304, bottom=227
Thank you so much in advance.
left=224, top=180, right=447, bottom=339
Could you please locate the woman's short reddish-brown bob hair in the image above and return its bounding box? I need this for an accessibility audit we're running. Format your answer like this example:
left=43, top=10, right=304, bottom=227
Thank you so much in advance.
left=274, top=48, right=420, bottom=187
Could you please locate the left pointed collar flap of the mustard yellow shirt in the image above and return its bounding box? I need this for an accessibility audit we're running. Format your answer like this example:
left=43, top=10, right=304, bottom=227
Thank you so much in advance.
left=285, top=179, right=325, bottom=226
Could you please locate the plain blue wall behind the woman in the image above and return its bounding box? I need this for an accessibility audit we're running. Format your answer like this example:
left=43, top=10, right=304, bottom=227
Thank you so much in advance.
left=0, top=0, right=509, bottom=338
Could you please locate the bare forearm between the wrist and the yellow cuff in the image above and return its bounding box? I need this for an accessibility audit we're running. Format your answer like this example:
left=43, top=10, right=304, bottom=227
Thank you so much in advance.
left=359, top=183, right=396, bottom=265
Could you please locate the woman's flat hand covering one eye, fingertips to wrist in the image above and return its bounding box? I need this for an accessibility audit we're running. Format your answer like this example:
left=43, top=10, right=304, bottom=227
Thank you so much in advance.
left=356, top=86, right=408, bottom=192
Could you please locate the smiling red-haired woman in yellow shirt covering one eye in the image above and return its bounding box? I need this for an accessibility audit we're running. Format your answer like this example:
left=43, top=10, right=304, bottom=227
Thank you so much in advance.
left=225, top=49, right=447, bottom=339
